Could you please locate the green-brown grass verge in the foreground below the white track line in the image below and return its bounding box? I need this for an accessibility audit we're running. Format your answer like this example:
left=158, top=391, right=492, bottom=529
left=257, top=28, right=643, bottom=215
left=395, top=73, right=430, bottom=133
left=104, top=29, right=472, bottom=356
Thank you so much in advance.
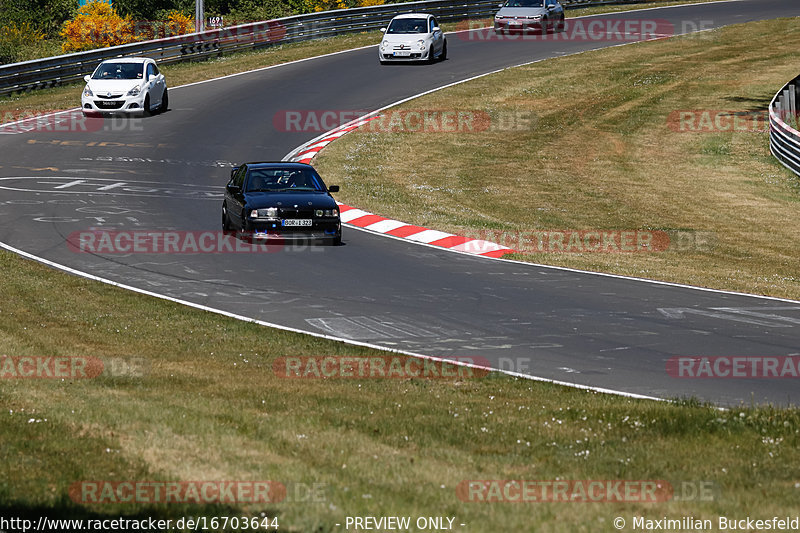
left=0, top=247, right=800, bottom=532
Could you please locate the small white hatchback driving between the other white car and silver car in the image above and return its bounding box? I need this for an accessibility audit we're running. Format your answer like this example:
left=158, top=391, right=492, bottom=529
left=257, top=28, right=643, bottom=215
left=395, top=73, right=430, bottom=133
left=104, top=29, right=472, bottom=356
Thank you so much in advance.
left=378, top=13, right=447, bottom=65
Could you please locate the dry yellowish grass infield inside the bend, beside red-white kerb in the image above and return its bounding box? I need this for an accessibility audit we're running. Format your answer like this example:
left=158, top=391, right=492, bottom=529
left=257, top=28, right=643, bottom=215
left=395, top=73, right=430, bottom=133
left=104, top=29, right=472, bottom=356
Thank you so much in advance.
left=314, top=19, right=800, bottom=299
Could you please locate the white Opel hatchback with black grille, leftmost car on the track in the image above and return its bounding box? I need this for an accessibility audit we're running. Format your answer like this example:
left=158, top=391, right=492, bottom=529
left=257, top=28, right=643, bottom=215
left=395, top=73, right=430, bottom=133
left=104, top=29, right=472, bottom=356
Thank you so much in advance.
left=81, top=57, right=169, bottom=115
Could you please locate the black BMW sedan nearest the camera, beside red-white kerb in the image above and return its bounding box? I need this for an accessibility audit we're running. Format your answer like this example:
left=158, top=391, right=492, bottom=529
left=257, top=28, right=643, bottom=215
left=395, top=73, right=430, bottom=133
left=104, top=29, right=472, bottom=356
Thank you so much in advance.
left=222, top=162, right=342, bottom=245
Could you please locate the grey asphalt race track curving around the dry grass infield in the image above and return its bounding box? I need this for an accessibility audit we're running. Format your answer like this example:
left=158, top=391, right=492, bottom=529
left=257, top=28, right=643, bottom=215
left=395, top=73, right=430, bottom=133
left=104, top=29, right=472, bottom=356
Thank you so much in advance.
left=0, top=0, right=800, bottom=404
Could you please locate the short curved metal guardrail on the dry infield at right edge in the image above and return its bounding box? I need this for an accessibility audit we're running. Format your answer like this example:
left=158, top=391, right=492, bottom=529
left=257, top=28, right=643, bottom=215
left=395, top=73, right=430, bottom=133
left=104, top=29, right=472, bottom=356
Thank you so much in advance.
left=769, top=76, right=800, bottom=176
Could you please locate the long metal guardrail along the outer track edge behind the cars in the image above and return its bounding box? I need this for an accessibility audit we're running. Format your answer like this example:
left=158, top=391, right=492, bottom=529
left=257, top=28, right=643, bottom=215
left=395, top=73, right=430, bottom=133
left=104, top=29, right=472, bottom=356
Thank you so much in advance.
left=0, top=0, right=648, bottom=95
